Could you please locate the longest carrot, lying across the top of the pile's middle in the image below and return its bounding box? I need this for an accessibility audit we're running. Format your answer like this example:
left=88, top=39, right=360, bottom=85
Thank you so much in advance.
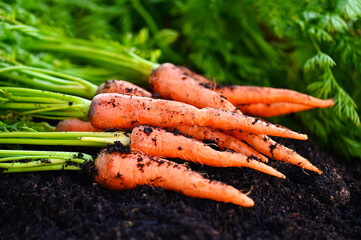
left=89, top=93, right=307, bottom=140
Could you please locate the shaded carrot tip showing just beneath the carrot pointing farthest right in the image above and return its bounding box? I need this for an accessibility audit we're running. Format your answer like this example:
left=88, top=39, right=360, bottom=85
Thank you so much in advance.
left=237, top=102, right=315, bottom=117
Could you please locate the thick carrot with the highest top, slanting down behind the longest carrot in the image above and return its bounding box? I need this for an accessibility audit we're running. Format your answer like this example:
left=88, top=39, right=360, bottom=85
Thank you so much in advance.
left=149, top=63, right=241, bottom=114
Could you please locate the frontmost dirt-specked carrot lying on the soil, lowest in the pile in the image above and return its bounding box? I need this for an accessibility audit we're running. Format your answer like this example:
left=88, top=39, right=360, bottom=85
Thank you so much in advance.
left=94, top=151, right=254, bottom=207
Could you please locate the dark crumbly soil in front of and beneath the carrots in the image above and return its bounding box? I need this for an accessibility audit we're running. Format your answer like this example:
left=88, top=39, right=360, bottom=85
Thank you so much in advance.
left=0, top=140, right=361, bottom=239
